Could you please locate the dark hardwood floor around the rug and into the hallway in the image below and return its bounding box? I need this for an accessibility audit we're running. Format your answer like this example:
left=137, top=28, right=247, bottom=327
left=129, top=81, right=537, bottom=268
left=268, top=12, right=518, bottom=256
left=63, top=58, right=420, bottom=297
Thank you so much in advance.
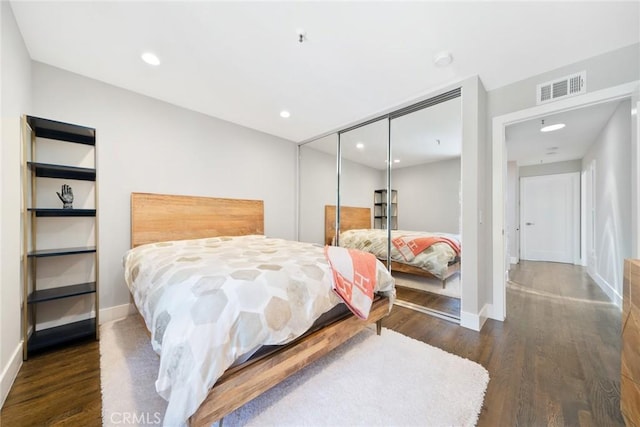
left=0, top=262, right=624, bottom=427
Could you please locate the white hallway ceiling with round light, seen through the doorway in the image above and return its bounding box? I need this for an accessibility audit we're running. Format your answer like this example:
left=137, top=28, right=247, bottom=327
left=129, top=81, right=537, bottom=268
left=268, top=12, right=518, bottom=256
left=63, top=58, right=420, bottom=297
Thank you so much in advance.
left=505, top=101, right=631, bottom=166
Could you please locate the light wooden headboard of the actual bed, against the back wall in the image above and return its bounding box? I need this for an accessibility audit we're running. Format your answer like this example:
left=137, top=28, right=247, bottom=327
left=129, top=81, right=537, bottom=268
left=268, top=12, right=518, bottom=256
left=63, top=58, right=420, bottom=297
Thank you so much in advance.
left=131, top=193, right=264, bottom=248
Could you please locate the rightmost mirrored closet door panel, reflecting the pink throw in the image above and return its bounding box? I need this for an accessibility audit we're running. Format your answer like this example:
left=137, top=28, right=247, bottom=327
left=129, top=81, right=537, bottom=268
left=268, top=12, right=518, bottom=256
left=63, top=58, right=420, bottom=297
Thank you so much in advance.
left=390, top=90, right=462, bottom=321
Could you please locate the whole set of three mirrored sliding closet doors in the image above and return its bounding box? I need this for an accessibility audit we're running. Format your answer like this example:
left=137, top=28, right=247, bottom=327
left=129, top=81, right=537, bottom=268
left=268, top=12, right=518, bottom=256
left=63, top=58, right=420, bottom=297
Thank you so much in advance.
left=299, top=88, right=462, bottom=321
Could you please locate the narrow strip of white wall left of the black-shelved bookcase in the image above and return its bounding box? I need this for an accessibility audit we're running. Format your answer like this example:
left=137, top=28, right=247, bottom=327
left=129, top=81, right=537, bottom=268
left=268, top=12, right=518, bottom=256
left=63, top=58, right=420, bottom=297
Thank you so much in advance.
left=0, top=1, right=31, bottom=406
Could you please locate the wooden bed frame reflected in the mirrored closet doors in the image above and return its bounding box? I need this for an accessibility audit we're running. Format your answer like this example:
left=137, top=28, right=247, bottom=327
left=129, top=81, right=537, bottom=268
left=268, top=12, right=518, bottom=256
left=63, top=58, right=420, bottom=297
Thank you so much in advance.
left=324, top=205, right=460, bottom=289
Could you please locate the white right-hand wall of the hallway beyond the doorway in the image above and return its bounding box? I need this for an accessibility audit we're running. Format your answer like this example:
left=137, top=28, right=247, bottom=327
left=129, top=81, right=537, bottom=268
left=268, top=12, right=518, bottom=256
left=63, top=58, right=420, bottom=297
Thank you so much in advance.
left=582, top=100, right=632, bottom=306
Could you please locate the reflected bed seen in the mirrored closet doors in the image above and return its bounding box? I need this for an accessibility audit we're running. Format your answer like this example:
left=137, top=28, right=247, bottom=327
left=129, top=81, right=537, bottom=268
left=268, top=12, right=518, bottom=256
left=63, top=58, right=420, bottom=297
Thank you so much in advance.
left=325, top=205, right=461, bottom=288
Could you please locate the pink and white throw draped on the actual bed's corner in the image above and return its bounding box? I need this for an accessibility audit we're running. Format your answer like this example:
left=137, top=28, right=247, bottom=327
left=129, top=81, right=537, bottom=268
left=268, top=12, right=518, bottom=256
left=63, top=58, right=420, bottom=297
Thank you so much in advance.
left=324, top=246, right=377, bottom=320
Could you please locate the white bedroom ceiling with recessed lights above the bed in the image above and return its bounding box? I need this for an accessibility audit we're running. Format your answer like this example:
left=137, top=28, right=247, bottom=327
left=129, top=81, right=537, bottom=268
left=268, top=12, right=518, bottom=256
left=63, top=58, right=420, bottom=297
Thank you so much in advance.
left=11, top=1, right=640, bottom=142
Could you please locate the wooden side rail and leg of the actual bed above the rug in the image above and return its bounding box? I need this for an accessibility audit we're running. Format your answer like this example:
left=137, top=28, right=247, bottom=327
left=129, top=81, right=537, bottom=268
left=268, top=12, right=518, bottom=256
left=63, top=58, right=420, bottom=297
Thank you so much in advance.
left=189, top=298, right=389, bottom=426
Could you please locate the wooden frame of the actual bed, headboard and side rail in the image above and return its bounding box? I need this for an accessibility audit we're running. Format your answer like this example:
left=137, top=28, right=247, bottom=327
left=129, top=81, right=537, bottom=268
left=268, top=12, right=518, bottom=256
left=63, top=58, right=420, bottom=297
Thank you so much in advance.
left=131, top=193, right=390, bottom=426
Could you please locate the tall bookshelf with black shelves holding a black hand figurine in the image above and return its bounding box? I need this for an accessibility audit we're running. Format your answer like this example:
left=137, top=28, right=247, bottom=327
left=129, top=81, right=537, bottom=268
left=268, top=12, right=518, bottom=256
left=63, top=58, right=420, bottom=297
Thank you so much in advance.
left=22, top=115, right=100, bottom=360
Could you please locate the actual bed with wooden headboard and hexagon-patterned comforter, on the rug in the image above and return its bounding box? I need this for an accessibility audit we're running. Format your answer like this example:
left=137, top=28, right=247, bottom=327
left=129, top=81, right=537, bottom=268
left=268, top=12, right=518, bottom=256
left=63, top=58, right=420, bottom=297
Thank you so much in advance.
left=124, top=193, right=395, bottom=426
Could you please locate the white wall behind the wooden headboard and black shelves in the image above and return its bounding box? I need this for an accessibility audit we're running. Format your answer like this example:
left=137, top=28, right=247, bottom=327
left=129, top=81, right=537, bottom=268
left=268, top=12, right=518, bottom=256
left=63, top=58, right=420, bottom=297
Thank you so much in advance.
left=29, top=62, right=296, bottom=321
